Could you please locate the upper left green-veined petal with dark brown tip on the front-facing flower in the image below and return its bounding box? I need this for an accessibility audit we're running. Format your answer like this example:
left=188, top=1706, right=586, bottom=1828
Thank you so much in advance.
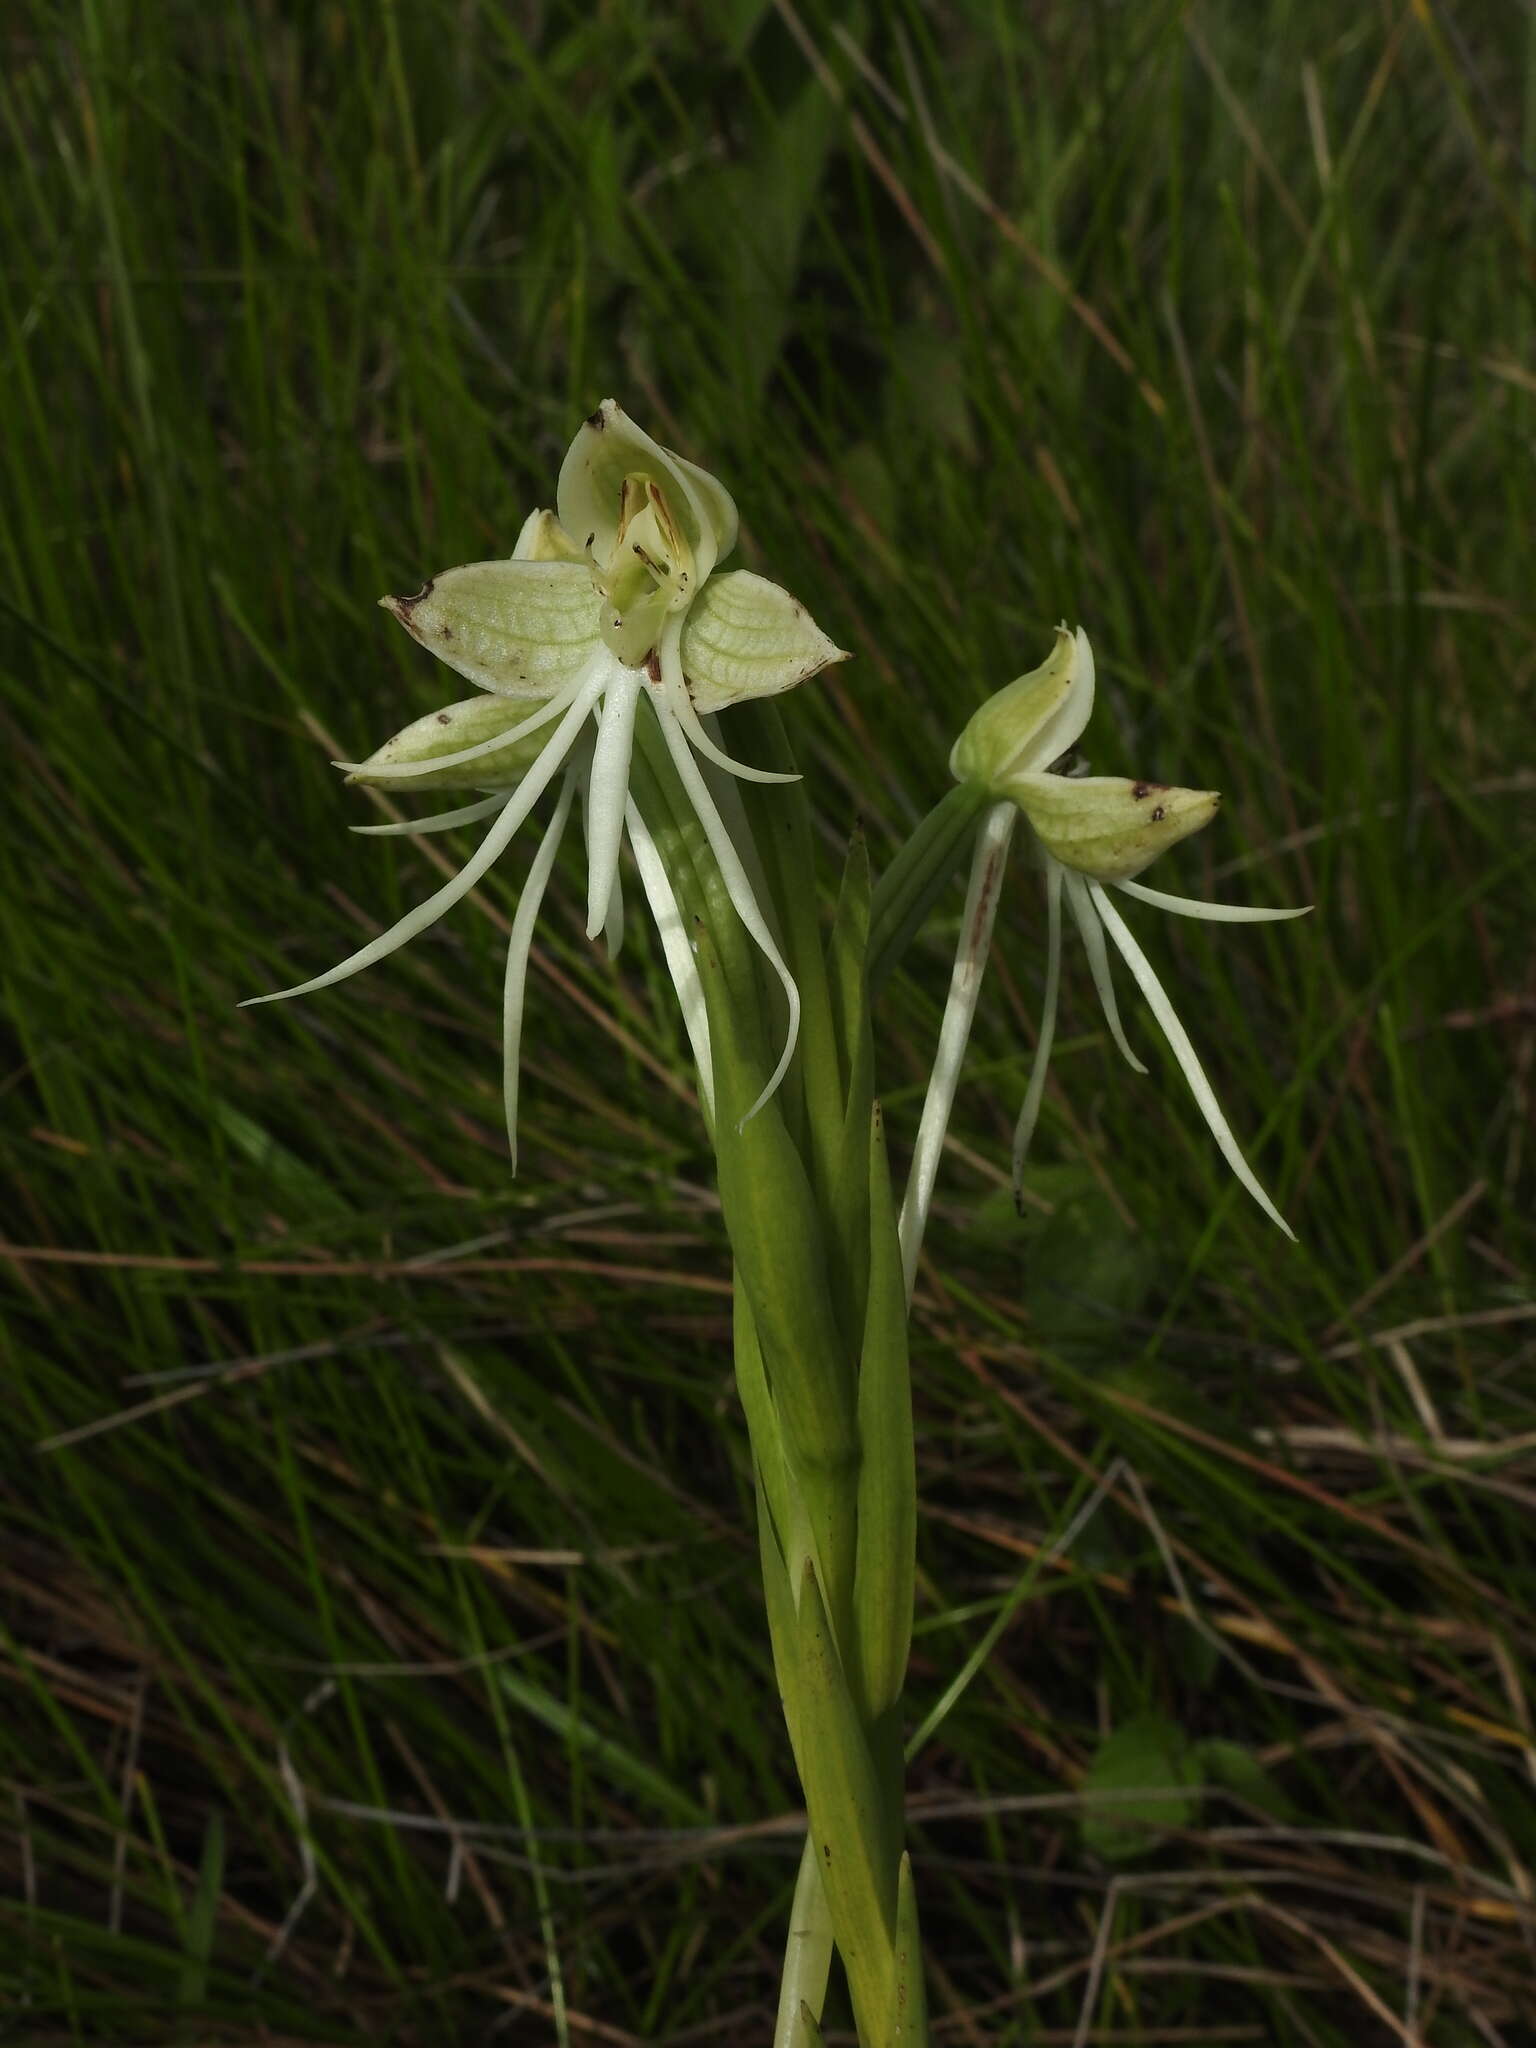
left=379, top=557, right=600, bottom=698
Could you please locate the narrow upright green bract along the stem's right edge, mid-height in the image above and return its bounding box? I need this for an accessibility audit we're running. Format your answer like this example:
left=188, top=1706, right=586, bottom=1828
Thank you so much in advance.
left=854, top=1102, right=918, bottom=1722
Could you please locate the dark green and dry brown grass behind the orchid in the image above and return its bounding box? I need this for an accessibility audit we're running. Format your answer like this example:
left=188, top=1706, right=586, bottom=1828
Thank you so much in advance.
left=0, top=0, right=1536, bottom=2048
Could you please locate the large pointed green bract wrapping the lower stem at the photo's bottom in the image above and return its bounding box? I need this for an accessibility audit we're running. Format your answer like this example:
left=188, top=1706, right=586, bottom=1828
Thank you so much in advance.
left=795, top=1559, right=897, bottom=2042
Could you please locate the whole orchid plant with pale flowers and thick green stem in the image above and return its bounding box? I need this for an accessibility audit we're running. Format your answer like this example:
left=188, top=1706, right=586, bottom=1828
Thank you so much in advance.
left=254, top=399, right=1298, bottom=2048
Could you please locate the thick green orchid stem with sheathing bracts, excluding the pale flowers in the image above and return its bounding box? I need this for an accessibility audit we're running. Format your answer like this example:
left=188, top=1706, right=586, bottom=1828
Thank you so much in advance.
left=633, top=707, right=925, bottom=2048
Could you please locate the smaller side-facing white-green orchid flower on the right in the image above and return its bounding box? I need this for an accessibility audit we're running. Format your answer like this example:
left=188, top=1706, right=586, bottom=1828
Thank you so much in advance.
left=901, top=625, right=1309, bottom=1288
